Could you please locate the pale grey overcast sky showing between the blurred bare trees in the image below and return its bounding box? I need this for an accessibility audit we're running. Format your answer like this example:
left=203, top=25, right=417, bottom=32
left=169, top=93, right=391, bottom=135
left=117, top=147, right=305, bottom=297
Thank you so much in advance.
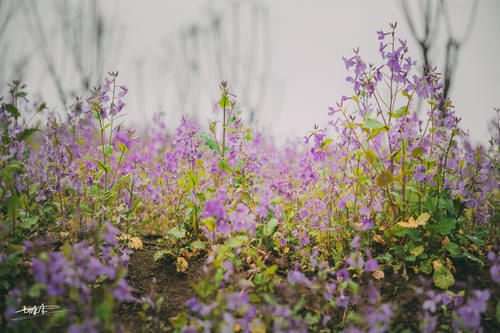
left=4, top=0, right=500, bottom=142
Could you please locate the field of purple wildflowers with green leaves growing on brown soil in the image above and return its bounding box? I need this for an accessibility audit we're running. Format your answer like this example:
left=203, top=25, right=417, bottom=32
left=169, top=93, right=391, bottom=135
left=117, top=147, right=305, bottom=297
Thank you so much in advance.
left=0, top=24, right=500, bottom=333
